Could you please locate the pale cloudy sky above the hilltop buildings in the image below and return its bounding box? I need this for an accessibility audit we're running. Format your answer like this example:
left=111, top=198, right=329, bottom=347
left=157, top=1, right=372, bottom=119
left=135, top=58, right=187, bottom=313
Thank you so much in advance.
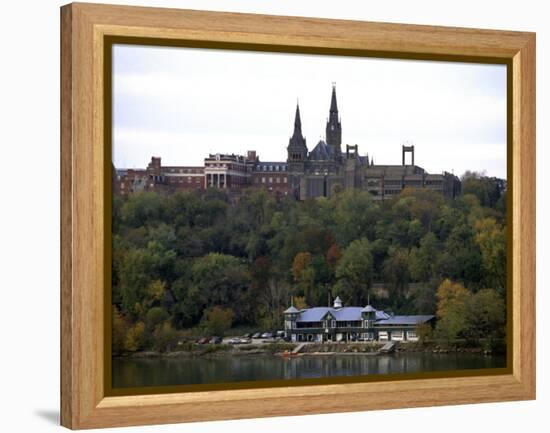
left=113, top=45, right=506, bottom=178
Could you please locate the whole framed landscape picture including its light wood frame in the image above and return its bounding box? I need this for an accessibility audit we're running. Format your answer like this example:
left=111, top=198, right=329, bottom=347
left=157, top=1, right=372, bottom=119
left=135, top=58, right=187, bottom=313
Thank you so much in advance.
left=61, top=4, right=535, bottom=429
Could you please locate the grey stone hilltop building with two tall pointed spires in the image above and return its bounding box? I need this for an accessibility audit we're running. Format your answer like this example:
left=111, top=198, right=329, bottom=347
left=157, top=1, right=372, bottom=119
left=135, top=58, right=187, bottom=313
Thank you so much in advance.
left=287, top=85, right=460, bottom=200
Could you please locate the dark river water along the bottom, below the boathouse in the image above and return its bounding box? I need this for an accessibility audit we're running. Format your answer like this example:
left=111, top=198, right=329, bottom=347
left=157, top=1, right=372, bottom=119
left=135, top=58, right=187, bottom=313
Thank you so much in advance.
left=113, top=352, right=506, bottom=388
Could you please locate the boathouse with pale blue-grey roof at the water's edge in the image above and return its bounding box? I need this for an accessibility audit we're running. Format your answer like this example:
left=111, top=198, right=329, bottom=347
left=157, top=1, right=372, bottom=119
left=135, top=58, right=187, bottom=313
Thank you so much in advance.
left=284, top=297, right=435, bottom=343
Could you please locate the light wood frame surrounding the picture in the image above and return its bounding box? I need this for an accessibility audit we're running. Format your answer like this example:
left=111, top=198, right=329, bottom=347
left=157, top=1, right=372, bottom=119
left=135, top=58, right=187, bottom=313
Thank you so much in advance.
left=61, top=3, right=535, bottom=429
